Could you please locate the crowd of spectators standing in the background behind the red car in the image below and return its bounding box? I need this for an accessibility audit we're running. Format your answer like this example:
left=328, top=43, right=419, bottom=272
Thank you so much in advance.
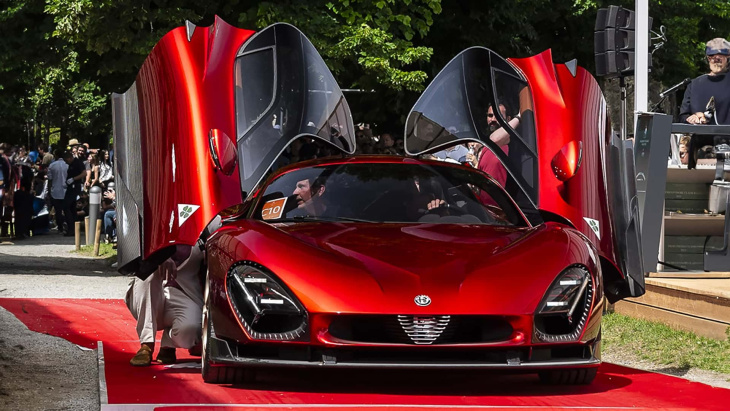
left=0, top=124, right=476, bottom=242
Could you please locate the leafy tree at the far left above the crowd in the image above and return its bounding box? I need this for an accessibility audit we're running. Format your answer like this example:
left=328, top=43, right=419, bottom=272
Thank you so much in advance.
left=0, top=0, right=108, bottom=149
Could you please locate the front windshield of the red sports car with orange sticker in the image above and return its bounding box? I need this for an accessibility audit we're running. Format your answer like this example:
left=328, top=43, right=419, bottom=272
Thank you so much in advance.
left=254, top=162, right=527, bottom=226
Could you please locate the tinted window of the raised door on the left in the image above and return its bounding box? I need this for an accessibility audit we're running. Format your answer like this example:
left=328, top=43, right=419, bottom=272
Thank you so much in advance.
left=236, top=24, right=354, bottom=196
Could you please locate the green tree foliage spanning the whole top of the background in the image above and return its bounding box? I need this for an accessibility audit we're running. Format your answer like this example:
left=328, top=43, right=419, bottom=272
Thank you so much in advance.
left=0, top=0, right=730, bottom=146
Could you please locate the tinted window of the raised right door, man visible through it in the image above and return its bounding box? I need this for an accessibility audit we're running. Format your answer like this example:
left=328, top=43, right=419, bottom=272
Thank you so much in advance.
left=405, top=47, right=540, bottom=224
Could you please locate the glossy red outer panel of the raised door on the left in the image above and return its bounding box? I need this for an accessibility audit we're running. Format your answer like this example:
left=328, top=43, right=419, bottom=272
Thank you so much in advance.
left=114, top=18, right=254, bottom=271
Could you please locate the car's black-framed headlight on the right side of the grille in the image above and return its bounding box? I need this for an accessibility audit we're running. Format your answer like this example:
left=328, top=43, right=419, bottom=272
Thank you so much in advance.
left=535, top=266, right=593, bottom=342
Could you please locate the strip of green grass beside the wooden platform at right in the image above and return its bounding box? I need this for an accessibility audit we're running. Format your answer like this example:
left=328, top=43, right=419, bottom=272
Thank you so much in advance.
left=602, top=313, right=730, bottom=374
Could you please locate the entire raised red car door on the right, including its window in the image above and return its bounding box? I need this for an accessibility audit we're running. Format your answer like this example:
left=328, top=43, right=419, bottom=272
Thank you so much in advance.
left=405, top=47, right=645, bottom=302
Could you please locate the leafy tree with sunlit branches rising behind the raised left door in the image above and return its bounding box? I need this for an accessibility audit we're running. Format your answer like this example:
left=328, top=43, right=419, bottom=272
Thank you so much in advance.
left=46, top=0, right=441, bottom=134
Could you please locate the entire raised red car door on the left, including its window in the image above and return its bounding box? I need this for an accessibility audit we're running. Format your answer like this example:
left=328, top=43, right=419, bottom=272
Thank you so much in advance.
left=112, top=18, right=355, bottom=278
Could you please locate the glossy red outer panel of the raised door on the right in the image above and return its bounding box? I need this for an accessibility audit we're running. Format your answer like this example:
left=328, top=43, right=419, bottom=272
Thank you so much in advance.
left=509, top=50, right=618, bottom=276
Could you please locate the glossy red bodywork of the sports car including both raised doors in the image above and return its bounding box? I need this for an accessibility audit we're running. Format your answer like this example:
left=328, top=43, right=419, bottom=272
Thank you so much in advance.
left=109, top=19, right=633, bottom=384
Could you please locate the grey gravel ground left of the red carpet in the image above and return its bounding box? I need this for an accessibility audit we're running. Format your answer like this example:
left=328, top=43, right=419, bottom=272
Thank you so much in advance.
left=0, top=233, right=129, bottom=410
